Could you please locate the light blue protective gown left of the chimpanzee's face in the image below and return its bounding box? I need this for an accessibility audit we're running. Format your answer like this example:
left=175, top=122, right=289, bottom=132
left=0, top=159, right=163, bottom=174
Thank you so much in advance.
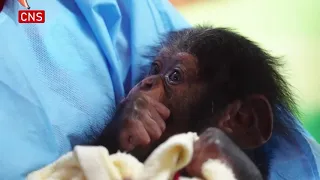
left=0, top=0, right=189, bottom=180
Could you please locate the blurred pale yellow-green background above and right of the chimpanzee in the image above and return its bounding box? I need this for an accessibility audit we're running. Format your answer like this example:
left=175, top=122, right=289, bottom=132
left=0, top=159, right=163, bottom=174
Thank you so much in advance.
left=172, top=0, right=320, bottom=142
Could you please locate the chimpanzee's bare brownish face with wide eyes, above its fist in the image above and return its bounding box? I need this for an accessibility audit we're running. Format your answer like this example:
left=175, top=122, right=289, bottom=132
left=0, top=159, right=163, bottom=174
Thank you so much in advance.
left=129, top=48, right=209, bottom=159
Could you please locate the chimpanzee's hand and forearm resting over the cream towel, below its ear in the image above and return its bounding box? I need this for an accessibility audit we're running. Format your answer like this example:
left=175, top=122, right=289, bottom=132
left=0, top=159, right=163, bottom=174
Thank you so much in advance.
left=186, top=128, right=262, bottom=180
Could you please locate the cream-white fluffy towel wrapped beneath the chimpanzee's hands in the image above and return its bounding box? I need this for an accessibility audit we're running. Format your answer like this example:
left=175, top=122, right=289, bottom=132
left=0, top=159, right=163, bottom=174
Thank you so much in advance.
left=27, top=133, right=235, bottom=180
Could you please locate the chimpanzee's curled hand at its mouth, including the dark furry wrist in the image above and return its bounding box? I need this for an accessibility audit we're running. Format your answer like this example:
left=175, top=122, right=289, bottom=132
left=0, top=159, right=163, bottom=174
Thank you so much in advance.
left=94, top=93, right=170, bottom=153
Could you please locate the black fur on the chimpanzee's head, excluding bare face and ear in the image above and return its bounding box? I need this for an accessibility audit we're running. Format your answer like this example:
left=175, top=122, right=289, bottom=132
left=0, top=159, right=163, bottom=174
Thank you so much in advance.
left=96, top=26, right=296, bottom=178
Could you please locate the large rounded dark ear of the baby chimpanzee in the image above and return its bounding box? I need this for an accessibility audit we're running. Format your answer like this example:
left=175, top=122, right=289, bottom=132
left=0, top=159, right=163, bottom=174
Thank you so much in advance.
left=218, top=95, right=273, bottom=149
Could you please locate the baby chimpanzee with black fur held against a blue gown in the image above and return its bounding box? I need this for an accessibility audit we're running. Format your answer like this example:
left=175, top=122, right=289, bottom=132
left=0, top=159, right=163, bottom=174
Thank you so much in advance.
left=98, top=26, right=295, bottom=180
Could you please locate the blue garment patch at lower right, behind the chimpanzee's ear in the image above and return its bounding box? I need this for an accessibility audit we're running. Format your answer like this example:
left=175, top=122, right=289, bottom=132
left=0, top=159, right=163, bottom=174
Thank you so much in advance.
left=264, top=106, right=320, bottom=180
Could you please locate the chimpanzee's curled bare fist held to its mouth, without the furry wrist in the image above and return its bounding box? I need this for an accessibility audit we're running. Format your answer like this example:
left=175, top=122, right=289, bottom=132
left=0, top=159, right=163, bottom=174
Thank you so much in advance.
left=119, top=93, right=170, bottom=151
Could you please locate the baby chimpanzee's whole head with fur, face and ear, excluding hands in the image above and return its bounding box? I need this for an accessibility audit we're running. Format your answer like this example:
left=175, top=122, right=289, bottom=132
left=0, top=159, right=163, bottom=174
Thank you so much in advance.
left=119, top=26, right=294, bottom=162
